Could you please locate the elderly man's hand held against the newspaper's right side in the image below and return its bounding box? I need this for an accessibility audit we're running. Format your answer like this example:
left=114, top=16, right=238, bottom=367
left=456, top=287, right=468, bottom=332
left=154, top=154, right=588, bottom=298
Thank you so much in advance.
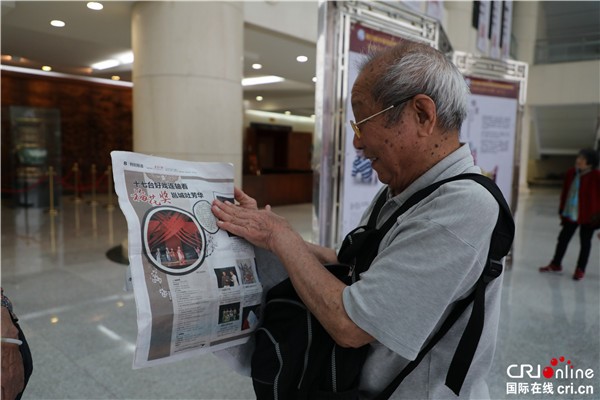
left=212, top=198, right=293, bottom=251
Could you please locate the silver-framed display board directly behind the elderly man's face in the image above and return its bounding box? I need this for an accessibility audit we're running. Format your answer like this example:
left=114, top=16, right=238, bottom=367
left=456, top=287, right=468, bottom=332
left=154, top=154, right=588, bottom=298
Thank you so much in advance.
left=313, top=2, right=440, bottom=247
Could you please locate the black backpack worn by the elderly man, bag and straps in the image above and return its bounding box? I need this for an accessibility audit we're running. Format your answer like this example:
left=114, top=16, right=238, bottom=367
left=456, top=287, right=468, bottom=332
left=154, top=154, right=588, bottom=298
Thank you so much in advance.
left=251, top=174, right=514, bottom=400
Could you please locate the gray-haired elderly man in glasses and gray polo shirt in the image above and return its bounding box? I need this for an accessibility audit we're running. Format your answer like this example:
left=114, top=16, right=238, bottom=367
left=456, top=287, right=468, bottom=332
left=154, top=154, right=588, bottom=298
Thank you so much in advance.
left=213, top=41, right=501, bottom=399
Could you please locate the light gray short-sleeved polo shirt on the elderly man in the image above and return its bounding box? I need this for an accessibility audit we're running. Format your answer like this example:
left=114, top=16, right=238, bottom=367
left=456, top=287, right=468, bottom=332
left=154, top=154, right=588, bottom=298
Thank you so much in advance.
left=343, top=144, right=502, bottom=399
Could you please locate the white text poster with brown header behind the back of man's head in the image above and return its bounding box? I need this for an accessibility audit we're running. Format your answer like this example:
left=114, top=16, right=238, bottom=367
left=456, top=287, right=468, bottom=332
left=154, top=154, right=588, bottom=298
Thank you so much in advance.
left=460, top=76, right=519, bottom=208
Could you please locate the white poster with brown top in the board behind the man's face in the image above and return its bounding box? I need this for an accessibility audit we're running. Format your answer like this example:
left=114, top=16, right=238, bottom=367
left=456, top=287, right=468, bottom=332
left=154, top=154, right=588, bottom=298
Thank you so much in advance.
left=339, top=22, right=403, bottom=241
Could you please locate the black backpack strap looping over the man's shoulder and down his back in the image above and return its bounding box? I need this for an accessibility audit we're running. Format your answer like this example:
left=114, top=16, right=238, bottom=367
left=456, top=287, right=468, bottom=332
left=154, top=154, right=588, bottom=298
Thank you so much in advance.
left=375, top=174, right=515, bottom=400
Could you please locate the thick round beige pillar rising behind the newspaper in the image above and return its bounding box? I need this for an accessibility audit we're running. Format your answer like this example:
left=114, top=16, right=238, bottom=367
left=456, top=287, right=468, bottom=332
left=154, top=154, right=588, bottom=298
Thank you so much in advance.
left=132, top=1, right=244, bottom=186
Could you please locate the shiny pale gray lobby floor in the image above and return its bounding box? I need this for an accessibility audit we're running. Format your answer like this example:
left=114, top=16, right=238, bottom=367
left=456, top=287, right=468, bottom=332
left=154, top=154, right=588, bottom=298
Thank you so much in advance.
left=1, top=188, right=600, bottom=399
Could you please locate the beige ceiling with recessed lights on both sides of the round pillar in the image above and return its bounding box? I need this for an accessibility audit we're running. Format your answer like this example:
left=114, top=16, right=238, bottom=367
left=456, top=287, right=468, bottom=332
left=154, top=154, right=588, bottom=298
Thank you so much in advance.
left=1, top=0, right=316, bottom=116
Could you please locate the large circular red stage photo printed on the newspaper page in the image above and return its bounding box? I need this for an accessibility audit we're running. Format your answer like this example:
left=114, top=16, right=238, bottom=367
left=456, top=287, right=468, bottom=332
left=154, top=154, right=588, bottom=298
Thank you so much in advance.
left=142, top=206, right=206, bottom=275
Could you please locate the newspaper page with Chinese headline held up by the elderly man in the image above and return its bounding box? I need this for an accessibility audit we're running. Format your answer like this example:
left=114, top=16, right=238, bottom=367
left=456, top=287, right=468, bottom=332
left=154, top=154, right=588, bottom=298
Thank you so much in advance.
left=111, top=151, right=263, bottom=368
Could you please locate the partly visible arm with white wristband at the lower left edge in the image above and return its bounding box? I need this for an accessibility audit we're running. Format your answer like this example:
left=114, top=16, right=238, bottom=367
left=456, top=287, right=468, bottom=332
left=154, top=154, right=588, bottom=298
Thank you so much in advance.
left=0, top=307, right=25, bottom=400
